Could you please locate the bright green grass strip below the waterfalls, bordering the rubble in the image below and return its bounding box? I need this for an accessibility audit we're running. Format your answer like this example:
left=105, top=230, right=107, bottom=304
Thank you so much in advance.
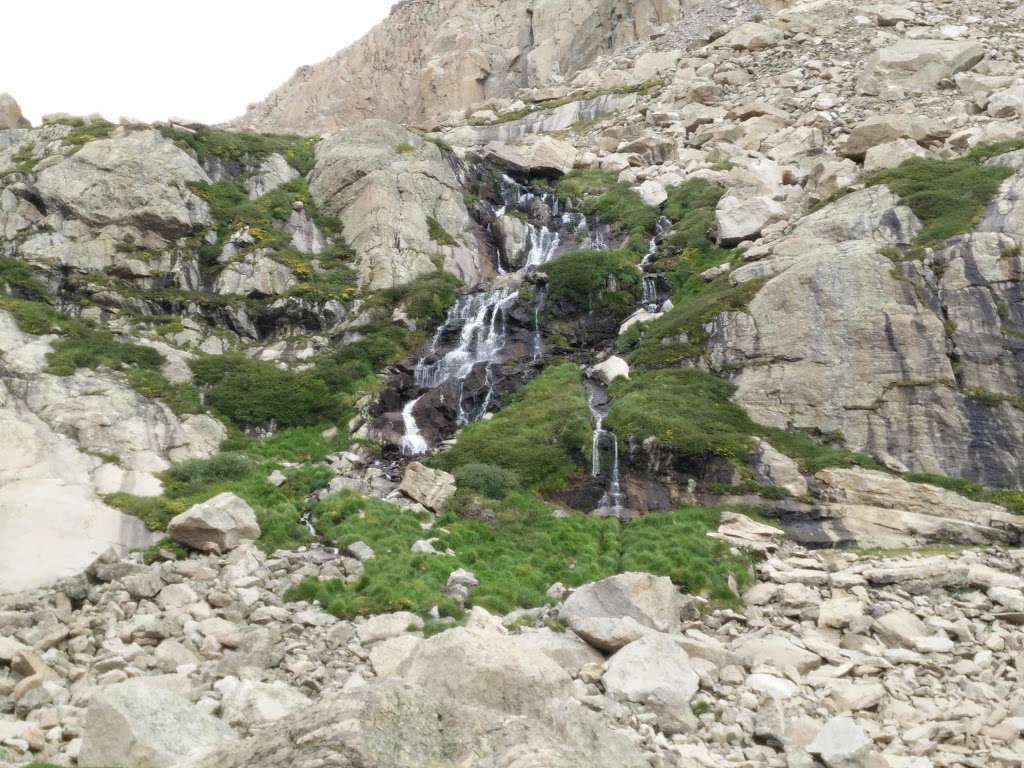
left=287, top=493, right=751, bottom=616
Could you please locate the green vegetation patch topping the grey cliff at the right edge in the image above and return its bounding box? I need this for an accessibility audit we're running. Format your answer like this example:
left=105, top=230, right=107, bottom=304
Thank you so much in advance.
left=864, top=151, right=1013, bottom=247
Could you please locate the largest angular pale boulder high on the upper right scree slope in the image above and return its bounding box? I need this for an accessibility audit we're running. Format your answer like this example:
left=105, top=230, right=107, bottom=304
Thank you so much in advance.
left=857, top=39, right=985, bottom=97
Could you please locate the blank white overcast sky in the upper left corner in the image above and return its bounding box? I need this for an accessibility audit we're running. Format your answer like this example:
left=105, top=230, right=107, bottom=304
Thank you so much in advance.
left=0, top=0, right=394, bottom=123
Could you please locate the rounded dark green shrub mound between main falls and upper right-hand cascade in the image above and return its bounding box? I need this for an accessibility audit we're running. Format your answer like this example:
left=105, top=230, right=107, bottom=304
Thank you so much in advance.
left=544, top=251, right=641, bottom=317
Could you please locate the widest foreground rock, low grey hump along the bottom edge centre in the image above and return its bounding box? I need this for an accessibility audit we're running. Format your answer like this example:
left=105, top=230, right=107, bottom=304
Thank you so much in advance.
left=180, top=679, right=648, bottom=768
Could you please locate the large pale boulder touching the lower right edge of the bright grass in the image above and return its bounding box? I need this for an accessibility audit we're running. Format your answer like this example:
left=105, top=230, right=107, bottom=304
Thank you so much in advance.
left=559, top=572, right=683, bottom=632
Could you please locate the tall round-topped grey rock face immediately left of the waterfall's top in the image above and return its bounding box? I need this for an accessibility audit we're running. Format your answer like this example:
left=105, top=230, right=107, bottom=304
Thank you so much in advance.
left=309, top=120, right=482, bottom=289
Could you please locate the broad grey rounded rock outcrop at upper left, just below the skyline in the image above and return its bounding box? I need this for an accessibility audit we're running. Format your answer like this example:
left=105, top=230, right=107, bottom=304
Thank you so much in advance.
left=36, top=130, right=210, bottom=239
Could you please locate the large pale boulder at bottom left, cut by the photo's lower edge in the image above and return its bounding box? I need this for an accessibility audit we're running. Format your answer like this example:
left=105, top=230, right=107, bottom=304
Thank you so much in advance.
left=78, top=680, right=234, bottom=768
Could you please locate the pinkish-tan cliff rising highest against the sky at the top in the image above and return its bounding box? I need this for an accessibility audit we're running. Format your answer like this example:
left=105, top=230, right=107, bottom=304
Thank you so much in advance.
left=233, top=0, right=683, bottom=134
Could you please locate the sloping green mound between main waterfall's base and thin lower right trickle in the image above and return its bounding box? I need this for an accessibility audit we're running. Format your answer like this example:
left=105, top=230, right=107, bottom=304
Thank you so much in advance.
left=431, top=364, right=591, bottom=490
